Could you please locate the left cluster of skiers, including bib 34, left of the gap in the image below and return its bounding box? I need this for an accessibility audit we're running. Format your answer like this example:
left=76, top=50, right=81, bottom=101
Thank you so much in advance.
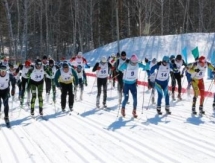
left=0, top=52, right=87, bottom=126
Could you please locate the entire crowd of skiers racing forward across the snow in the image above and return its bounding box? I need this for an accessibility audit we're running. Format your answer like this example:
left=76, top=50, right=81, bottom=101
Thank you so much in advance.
left=0, top=51, right=215, bottom=125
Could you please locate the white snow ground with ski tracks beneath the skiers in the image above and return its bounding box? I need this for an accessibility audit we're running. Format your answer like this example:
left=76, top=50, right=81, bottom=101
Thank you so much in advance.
left=0, top=33, right=215, bottom=163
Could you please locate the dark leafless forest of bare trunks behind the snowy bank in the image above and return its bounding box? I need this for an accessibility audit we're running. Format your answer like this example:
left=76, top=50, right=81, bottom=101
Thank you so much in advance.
left=0, top=0, right=215, bottom=61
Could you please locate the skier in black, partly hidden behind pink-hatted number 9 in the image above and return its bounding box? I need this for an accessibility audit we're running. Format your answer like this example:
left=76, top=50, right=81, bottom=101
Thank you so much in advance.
left=114, top=51, right=127, bottom=104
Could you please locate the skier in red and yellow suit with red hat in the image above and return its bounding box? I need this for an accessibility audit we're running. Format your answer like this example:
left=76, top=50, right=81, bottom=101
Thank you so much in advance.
left=188, top=56, right=215, bottom=114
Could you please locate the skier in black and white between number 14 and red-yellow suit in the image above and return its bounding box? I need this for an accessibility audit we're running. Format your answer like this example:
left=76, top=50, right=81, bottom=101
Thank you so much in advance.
left=170, top=54, right=187, bottom=100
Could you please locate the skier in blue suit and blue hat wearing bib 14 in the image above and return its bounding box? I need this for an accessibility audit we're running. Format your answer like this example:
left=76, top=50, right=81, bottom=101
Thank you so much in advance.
left=150, top=56, right=171, bottom=115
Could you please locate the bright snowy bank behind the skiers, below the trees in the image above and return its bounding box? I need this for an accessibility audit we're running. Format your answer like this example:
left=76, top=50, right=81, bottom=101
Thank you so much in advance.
left=85, top=33, right=215, bottom=65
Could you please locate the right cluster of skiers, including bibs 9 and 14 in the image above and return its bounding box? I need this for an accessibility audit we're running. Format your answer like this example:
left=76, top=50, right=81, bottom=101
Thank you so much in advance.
left=93, top=51, right=215, bottom=118
